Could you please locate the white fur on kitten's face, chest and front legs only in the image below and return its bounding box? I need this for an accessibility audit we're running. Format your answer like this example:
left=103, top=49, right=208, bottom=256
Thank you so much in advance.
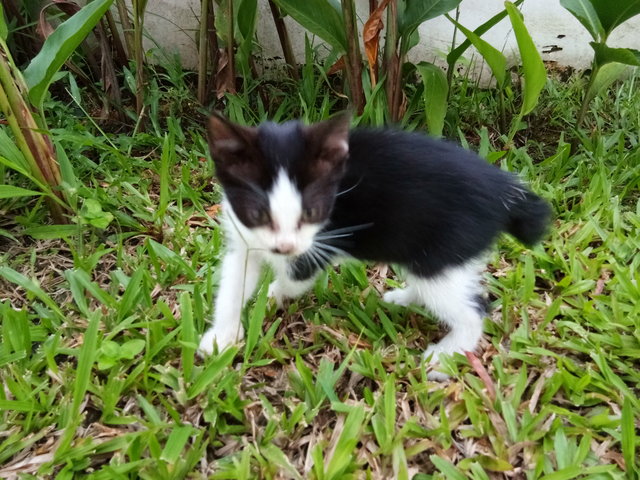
left=199, top=170, right=322, bottom=354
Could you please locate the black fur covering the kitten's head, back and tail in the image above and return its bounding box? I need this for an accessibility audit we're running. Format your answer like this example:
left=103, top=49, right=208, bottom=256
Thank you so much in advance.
left=212, top=117, right=551, bottom=280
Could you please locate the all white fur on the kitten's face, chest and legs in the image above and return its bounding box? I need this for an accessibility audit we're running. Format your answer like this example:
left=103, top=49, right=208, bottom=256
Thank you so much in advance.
left=199, top=171, right=483, bottom=380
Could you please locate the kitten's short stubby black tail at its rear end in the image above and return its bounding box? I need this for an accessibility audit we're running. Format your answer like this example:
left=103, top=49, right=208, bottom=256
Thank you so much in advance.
left=502, top=184, right=551, bottom=246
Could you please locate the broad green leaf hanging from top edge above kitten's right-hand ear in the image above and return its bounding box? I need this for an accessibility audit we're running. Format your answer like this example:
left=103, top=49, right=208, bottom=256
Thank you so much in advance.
left=274, top=0, right=347, bottom=52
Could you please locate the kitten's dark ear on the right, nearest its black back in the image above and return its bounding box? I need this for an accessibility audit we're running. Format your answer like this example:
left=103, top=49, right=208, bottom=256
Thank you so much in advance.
left=306, top=111, right=351, bottom=175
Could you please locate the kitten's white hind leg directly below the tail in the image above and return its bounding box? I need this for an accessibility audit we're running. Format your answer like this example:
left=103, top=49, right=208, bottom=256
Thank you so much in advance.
left=407, top=261, right=485, bottom=380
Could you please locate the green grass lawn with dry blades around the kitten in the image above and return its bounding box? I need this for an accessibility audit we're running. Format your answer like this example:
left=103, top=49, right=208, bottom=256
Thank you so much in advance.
left=0, top=67, right=640, bottom=480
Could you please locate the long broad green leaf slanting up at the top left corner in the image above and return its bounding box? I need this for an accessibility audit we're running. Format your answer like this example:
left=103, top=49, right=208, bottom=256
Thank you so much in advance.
left=23, top=0, right=113, bottom=107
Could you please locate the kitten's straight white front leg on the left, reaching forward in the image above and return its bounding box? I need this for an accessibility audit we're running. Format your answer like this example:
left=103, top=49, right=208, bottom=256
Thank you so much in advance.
left=198, top=247, right=262, bottom=355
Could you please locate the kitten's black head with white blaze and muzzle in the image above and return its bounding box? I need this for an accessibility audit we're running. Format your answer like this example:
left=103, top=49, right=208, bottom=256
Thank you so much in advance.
left=209, top=113, right=350, bottom=256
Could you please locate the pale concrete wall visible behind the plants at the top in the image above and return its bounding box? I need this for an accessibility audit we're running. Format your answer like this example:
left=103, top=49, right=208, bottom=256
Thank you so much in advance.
left=138, top=0, right=640, bottom=75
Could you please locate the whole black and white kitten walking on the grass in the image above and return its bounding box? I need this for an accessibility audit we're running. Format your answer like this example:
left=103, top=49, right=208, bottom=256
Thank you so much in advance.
left=200, top=114, right=550, bottom=378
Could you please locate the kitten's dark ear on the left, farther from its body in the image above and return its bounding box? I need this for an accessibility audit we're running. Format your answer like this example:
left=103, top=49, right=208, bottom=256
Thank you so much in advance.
left=208, top=112, right=257, bottom=164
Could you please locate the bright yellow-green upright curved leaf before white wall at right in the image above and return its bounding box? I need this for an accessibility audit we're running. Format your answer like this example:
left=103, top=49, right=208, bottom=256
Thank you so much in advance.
left=504, top=2, right=547, bottom=116
